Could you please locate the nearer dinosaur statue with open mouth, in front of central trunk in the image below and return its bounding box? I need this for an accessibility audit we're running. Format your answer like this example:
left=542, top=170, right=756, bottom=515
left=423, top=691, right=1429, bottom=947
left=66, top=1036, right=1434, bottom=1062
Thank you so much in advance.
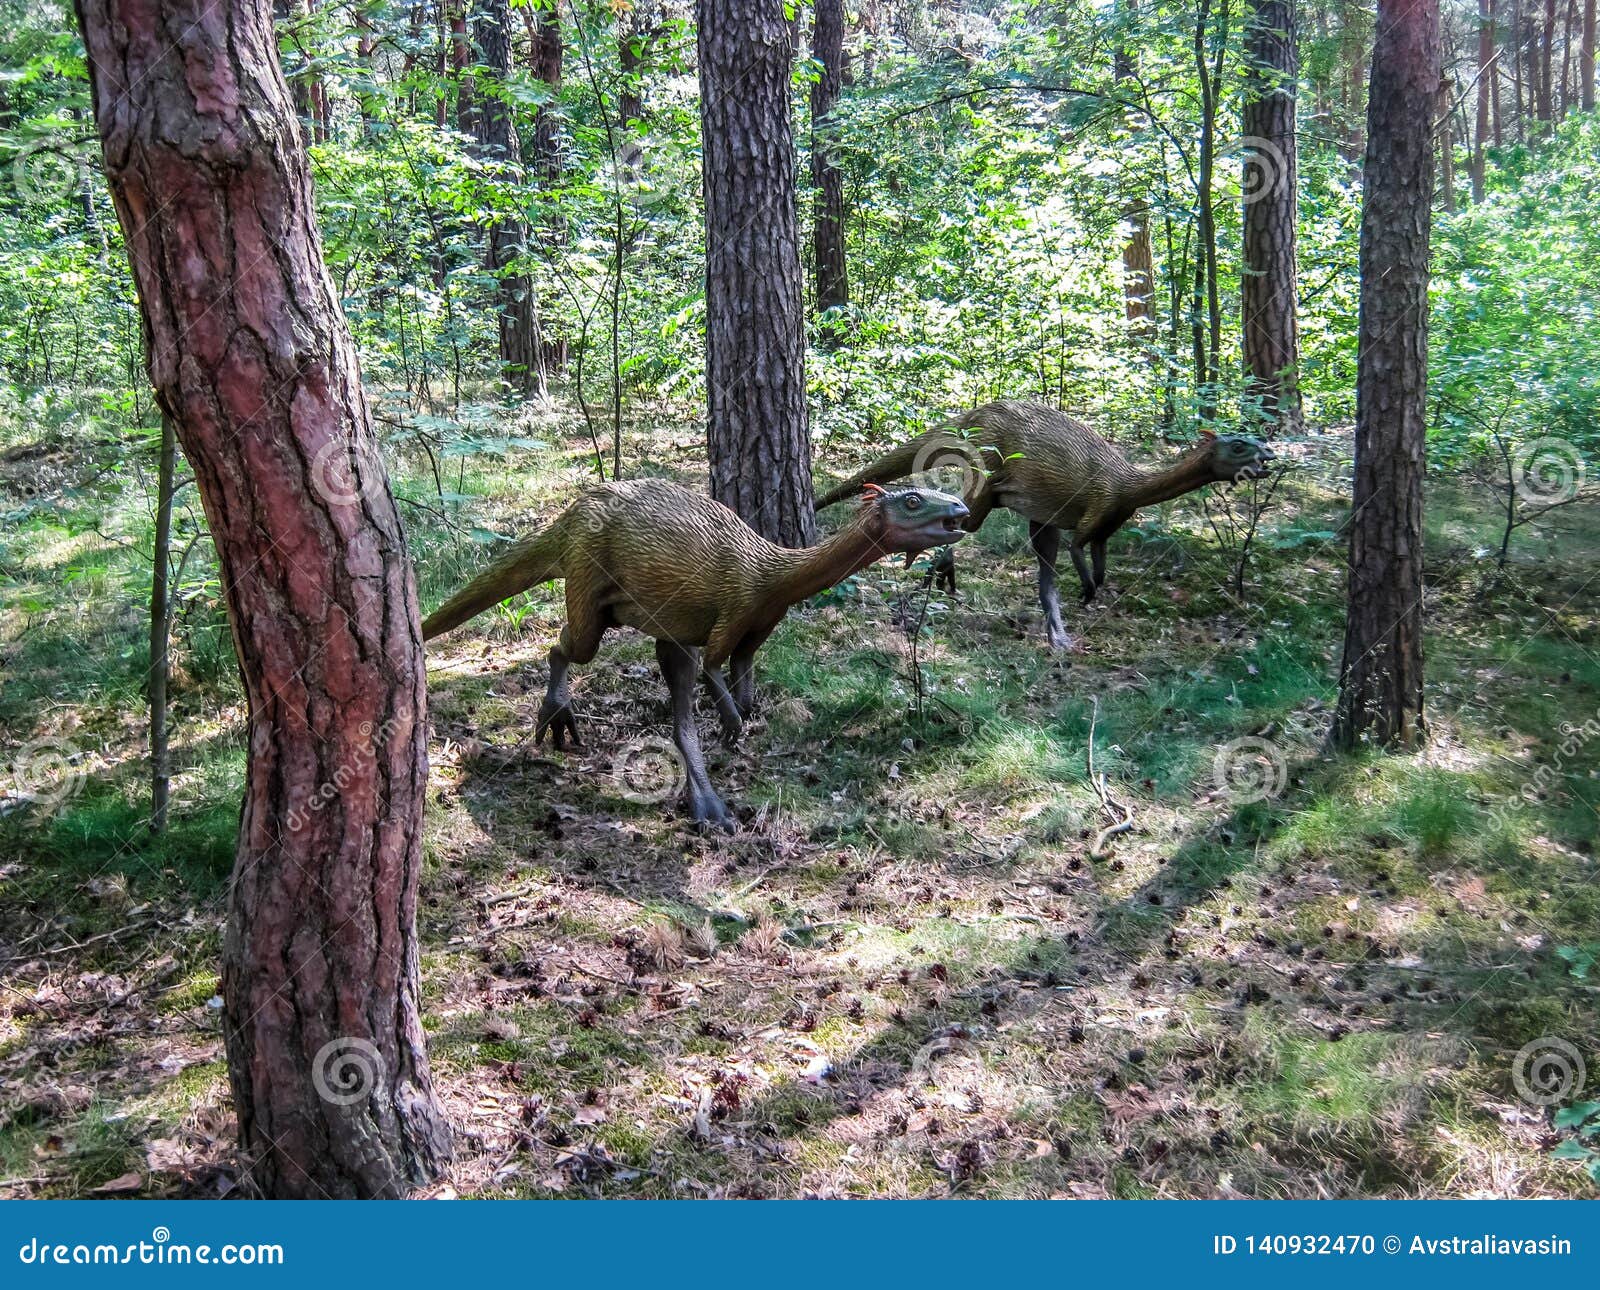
left=422, top=479, right=966, bottom=829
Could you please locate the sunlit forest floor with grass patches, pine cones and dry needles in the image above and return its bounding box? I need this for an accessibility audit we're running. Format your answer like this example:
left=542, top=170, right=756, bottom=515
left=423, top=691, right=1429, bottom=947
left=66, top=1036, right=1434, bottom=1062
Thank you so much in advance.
left=0, top=401, right=1600, bottom=1197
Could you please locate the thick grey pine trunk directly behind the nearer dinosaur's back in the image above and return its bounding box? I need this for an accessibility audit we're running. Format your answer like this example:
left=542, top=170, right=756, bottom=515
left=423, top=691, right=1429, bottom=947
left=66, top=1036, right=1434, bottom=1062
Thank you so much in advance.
left=696, top=0, right=814, bottom=546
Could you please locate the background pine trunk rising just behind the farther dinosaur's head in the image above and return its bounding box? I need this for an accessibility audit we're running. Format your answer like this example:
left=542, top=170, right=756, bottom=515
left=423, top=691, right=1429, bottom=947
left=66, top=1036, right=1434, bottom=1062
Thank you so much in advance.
left=1240, top=0, right=1301, bottom=434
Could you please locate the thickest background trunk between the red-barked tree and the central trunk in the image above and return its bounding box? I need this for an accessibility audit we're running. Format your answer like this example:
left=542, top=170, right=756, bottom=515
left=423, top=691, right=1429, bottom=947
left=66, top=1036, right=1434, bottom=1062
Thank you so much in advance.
left=474, top=0, right=546, bottom=399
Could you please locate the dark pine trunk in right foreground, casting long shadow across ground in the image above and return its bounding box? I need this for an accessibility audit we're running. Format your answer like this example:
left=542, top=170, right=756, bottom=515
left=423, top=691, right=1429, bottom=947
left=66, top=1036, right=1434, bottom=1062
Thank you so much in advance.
left=1333, top=0, right=1440, bottom=747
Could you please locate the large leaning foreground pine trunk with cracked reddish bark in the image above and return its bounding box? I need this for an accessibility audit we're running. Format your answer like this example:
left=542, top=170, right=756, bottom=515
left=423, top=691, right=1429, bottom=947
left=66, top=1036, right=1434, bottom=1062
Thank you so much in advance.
left=77, top=0, right=451, bottom=1197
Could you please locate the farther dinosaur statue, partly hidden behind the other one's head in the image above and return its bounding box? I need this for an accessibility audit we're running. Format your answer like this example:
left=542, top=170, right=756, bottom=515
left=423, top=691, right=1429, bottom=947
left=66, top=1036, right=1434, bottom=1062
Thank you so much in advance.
left=816, top=402, right=1275, bottom=650
